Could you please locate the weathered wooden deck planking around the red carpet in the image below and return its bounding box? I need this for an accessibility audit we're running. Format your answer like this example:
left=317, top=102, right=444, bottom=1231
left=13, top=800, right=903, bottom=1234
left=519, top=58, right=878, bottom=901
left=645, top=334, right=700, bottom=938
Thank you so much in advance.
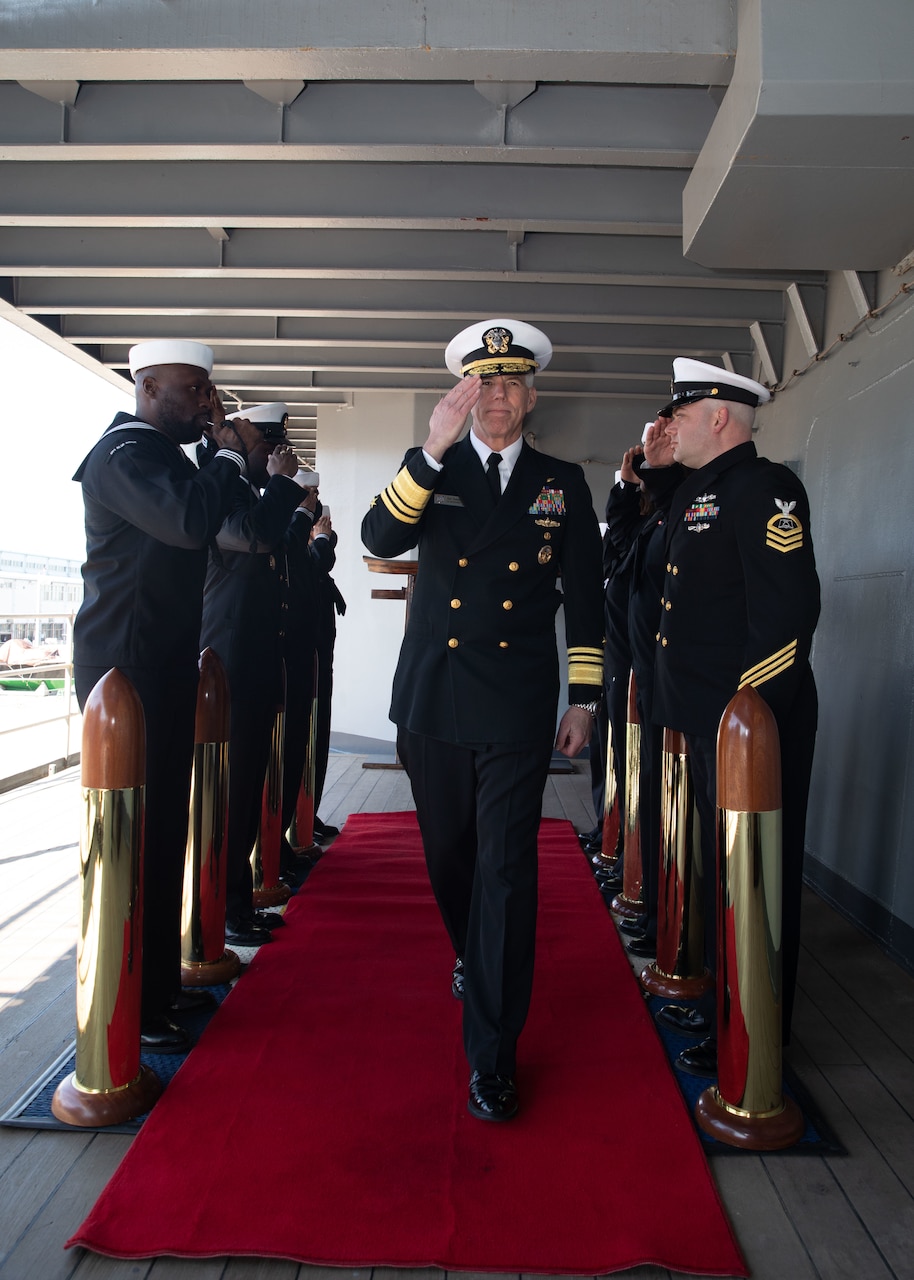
left=0, top=755, right=914, bottom=1280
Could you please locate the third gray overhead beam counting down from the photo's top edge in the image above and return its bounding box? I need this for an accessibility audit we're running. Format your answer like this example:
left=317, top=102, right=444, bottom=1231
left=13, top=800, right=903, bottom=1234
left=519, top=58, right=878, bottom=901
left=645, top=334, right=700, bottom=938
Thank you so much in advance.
left=0, top=161, right=686, bottom=228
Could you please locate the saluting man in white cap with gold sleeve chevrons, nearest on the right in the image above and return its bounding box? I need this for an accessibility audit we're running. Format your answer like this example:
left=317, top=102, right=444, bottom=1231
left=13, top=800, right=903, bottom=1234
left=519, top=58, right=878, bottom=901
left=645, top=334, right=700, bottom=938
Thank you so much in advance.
left=641, top=358, right=819, bottom=1075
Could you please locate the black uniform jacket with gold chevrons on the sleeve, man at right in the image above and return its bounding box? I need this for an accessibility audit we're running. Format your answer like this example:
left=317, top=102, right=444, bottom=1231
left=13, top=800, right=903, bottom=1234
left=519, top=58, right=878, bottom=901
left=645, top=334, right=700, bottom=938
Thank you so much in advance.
left=643, top=443, right=819, bottom=737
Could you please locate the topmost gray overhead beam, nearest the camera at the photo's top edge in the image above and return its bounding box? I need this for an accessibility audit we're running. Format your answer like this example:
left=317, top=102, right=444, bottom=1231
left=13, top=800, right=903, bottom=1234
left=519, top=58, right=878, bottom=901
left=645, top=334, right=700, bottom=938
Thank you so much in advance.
left=0, top=0, right=736, bottom=84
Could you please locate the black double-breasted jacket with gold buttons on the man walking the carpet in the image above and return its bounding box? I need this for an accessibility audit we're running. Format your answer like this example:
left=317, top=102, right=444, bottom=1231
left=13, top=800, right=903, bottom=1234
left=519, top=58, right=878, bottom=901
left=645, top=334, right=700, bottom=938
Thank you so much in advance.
left=362, top=436, right=603, bottom=744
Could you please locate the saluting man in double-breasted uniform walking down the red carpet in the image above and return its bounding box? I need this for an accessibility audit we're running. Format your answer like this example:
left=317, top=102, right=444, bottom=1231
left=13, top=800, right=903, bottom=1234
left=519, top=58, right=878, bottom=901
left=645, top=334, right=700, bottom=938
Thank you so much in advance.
left=362, top=320, right=603, bottom=1120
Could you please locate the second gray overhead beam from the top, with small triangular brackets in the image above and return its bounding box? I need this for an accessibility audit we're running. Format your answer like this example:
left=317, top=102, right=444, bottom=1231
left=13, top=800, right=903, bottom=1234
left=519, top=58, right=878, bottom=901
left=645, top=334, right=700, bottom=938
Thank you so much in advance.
left=0, top=82, right=717, bottom=156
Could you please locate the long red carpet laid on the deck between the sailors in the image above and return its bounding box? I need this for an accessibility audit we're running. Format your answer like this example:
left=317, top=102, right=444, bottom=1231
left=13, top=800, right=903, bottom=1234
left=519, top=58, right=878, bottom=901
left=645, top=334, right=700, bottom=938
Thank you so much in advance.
left=68, top=813, right=748, bottom=1276
